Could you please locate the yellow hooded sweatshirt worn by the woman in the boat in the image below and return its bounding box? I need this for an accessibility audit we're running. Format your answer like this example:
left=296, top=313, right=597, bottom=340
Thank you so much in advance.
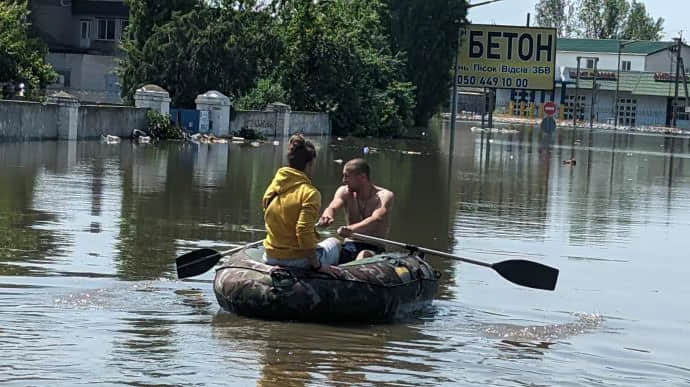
left=263, top=167, right=321, bottom=259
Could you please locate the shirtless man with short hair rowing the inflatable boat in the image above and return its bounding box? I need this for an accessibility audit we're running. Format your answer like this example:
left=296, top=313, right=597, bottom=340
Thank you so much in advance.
left=319, top=159, right=393, bottom=263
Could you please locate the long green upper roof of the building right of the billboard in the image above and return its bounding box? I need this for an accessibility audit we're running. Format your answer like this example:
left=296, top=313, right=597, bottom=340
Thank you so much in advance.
left=557, top=38, right=675, bottom=55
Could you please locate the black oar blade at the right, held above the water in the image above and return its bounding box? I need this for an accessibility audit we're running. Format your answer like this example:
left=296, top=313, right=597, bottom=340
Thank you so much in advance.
left=491, top=259, right=558, bottom=290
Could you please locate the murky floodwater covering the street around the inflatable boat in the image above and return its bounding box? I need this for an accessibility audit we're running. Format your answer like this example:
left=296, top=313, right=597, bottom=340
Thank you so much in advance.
left=0, top=124, right=690, bottom=386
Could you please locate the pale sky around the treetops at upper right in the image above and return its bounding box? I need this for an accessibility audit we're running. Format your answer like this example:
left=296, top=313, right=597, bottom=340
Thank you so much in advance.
left=469, top=0, right=690, bottom=40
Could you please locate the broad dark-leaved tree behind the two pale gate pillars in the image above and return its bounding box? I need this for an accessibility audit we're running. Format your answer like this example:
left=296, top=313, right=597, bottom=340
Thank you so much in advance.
left=120, top=1, right=280, bottom=107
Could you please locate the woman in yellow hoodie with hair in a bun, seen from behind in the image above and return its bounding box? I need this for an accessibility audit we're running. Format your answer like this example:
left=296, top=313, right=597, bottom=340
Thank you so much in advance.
left=263, top=135, right=340, bottom=270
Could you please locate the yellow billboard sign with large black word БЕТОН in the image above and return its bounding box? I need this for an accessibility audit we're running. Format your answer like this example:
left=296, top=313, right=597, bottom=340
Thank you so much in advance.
left=456, top=24, right=557, bottom=90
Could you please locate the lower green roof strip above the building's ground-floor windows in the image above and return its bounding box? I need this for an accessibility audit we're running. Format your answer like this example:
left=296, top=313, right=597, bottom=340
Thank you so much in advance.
left=567, top=68, right=685, bottom=97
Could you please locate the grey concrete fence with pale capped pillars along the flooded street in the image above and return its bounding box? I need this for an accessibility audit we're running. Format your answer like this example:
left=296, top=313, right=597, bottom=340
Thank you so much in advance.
left=0, top=85, right=331, bottom=141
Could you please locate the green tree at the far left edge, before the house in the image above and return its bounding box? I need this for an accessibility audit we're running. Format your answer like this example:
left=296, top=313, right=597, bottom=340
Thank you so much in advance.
left=0, top=1, right=57, bottom=97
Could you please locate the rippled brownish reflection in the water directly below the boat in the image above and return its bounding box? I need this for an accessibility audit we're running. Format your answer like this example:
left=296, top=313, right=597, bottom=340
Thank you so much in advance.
left=212, top=313, right=449, bottom=386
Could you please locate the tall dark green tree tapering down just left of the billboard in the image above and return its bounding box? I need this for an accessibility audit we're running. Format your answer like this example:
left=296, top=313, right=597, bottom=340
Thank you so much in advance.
left=382, top=0, right=467, bottom=125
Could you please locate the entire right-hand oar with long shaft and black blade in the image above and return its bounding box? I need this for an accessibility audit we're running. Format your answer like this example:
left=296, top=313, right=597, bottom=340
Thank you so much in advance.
left=352, top=233, right=558, bottom=290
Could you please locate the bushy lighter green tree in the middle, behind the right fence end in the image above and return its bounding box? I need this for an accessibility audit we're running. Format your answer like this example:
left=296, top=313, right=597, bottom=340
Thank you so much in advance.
left=276, top=0, right=414, bottom=136
